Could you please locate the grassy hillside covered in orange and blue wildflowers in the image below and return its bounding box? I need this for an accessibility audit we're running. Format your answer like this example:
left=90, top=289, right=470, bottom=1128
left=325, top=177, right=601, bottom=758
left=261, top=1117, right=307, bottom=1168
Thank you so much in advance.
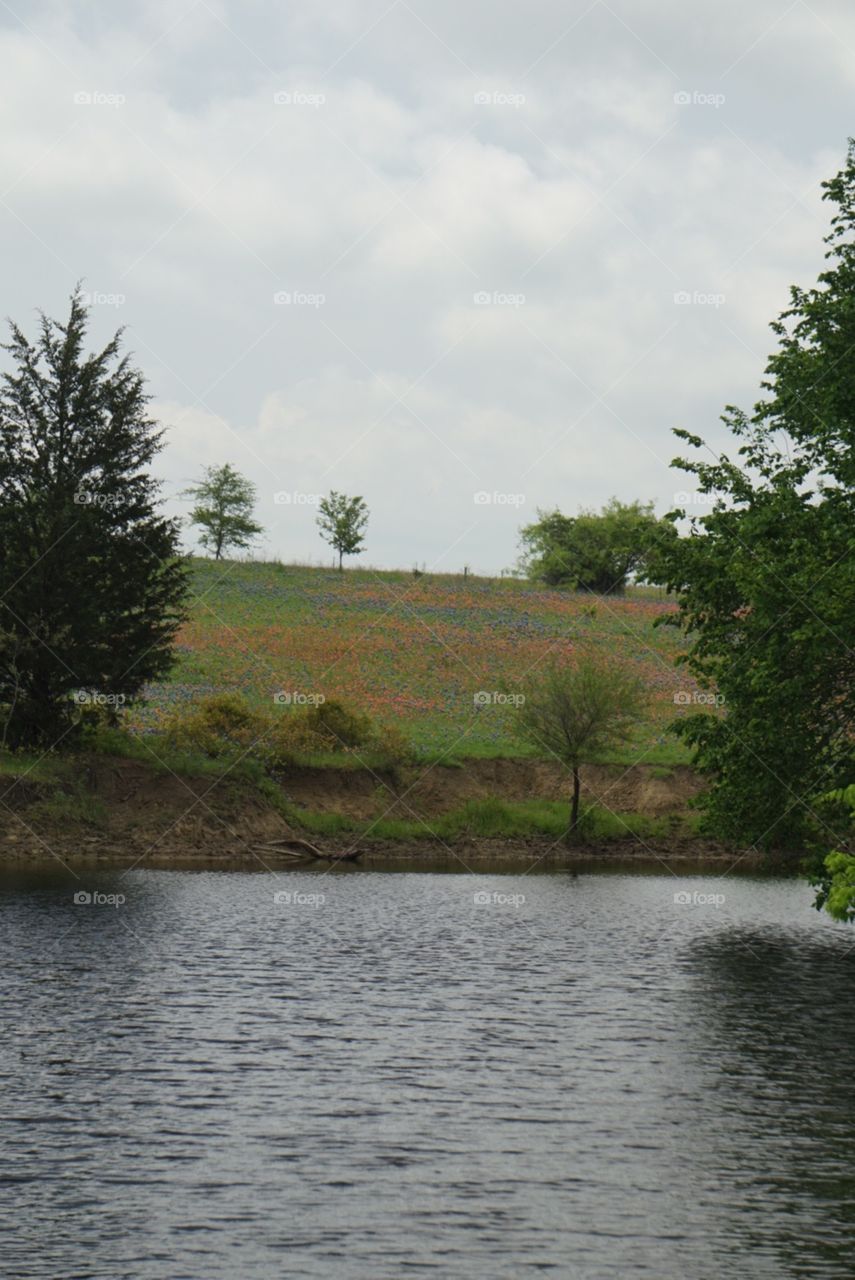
left=133, top=559, right=692, bottom=763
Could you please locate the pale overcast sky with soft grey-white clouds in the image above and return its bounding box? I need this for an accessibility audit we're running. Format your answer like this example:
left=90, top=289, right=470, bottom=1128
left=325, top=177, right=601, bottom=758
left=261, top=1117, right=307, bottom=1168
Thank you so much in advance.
left=0, top=0, right=855, bottom=573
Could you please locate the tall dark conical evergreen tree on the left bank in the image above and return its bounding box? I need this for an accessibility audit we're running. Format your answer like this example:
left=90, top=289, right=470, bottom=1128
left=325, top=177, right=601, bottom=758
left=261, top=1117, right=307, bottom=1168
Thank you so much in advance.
left=0, top=289, right=187, bottom=748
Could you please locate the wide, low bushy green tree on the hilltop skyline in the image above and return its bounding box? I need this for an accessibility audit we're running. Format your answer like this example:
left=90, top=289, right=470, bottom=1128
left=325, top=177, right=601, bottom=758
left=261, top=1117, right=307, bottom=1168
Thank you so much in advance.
left=520, top=498, right=673, bottom=595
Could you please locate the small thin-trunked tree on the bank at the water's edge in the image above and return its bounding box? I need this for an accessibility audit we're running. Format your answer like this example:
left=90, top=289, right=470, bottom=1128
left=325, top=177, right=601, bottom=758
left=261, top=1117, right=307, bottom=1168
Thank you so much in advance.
left=516, top=655, right=644, bottom=841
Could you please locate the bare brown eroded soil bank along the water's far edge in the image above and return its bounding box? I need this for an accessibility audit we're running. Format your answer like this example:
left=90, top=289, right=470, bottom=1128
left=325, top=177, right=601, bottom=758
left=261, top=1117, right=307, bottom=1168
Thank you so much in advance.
left=0, top=756, right=762, bottom=870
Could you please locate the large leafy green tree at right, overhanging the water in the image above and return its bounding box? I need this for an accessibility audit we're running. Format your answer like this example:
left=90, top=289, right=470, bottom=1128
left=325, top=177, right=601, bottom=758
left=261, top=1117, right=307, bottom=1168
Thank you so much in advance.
left=658, top=143, right=855, bottom=847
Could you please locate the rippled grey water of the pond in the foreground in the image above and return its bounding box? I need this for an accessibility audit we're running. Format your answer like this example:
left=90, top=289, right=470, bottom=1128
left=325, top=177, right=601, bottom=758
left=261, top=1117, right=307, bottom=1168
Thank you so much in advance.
left=0, top=870, right=855, bottom=1280
